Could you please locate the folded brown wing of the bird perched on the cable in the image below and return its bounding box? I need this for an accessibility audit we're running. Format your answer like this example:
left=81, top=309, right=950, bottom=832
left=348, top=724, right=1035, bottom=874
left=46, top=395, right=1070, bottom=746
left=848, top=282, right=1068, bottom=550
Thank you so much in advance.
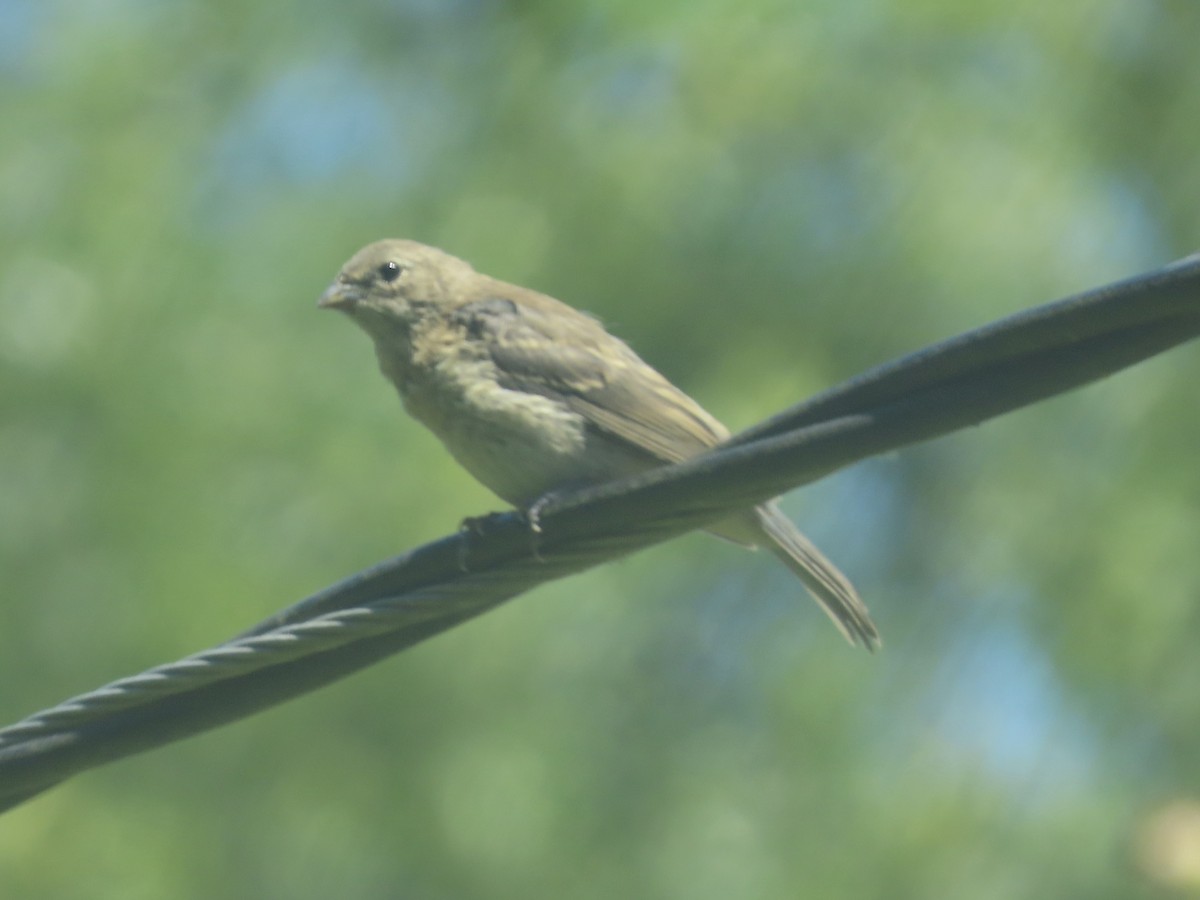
left=455, top=292, right=728, bottom=462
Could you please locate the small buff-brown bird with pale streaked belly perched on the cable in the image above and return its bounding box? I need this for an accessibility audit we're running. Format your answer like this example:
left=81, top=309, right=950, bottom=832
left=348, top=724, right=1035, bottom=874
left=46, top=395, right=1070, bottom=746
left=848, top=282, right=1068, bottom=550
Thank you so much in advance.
left=318, top=240, right=880, bottom=649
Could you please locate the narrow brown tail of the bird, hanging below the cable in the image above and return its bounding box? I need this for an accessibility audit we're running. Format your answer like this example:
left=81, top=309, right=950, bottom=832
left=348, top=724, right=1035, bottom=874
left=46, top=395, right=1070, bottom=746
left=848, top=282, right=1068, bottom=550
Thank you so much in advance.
left=751, top=503, right=883, bottom=650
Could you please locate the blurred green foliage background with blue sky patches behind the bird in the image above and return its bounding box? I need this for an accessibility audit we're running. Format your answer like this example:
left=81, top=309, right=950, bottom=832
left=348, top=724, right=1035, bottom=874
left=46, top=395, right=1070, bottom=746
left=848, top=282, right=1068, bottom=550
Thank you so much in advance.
left=0, top=0, right=1200, bottom=900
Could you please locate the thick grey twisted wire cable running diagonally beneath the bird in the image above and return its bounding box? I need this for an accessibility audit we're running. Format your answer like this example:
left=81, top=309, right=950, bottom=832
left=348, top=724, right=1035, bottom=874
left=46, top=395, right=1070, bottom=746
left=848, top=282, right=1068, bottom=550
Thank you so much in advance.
left=0, top=257, right=1200, bottom=810
